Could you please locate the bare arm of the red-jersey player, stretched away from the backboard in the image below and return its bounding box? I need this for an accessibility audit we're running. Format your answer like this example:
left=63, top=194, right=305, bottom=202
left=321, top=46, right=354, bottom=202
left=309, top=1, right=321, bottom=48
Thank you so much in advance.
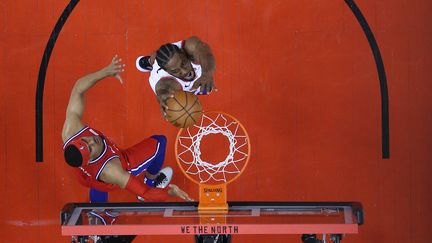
left=62, top=55, right=125, bottom=142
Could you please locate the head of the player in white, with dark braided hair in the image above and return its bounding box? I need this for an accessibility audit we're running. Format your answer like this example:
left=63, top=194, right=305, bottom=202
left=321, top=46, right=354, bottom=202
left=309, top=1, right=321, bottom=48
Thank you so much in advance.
left=156, top=43, right=195, bottom=81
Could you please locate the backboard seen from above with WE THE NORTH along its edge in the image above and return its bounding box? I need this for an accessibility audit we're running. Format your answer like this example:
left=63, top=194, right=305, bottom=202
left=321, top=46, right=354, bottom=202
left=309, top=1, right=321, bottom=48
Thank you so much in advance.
left=61, top=202, right=363, bottom=241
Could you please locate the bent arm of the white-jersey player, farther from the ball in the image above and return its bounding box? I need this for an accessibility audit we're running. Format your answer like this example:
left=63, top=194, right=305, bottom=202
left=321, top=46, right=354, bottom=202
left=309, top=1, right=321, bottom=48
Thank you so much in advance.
left=185, top=36, right=216, bottom=93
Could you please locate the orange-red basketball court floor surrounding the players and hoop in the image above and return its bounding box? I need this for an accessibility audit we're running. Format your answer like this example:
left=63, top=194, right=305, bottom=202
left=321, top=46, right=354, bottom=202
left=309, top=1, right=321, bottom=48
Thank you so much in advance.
left=0, top=0, right=432, bottom=243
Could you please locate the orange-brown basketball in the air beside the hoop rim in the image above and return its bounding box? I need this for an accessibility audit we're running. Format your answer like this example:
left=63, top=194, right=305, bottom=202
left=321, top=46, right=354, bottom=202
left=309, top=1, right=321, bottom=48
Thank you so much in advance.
left=166, top=91, right=202, bottom=128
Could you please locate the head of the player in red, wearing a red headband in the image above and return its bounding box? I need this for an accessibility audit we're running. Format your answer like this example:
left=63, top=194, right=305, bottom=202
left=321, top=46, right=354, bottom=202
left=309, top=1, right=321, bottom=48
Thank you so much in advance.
left=64, top=136, right=104, bottom=167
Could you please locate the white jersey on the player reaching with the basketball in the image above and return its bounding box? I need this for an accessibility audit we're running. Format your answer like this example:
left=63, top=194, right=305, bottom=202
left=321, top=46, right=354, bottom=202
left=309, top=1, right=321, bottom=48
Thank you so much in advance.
left=149, top=41, right=202, bottom=94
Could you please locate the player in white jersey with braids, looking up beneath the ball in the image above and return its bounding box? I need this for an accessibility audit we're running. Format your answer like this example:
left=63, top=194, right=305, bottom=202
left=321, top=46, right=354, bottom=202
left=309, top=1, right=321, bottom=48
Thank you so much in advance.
left=136, top=36, right=216, bottom=116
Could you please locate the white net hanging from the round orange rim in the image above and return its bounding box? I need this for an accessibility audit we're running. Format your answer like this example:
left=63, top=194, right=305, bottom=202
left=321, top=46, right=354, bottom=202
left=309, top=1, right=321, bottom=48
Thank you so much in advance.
left=176, top=113, right=250, bottom=184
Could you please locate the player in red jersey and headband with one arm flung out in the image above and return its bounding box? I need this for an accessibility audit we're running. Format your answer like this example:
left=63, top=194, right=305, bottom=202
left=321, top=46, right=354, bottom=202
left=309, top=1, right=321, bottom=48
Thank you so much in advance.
left=62, top=55, right=192, bottom=202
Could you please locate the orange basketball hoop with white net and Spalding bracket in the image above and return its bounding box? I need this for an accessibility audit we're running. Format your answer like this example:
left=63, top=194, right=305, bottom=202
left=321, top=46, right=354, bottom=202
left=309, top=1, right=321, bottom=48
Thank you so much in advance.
left=175, top=111, right=250, bottom=211
